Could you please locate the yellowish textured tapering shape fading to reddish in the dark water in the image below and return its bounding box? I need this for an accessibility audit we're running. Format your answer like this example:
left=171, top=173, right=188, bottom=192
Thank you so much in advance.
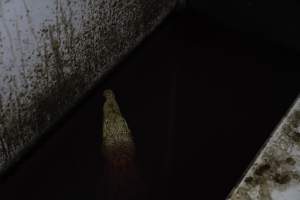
left=102, top=90, right=141, bottom=200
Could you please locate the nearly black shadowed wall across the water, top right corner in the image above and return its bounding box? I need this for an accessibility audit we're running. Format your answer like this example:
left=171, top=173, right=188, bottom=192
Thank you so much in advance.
left=189, top=0, right=300, bottom=51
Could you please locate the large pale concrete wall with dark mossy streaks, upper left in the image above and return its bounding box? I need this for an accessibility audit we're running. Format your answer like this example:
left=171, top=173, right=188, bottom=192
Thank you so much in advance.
left=0, top=0, right=176, bottom=172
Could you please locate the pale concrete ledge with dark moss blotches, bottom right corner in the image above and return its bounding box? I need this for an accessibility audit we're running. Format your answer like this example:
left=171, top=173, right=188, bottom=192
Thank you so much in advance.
left=228, top=96, right=300, bottom=200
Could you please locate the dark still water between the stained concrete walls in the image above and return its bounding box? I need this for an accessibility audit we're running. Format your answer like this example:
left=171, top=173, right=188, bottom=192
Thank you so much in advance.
left=0, top=8, right=300, bottom=200
